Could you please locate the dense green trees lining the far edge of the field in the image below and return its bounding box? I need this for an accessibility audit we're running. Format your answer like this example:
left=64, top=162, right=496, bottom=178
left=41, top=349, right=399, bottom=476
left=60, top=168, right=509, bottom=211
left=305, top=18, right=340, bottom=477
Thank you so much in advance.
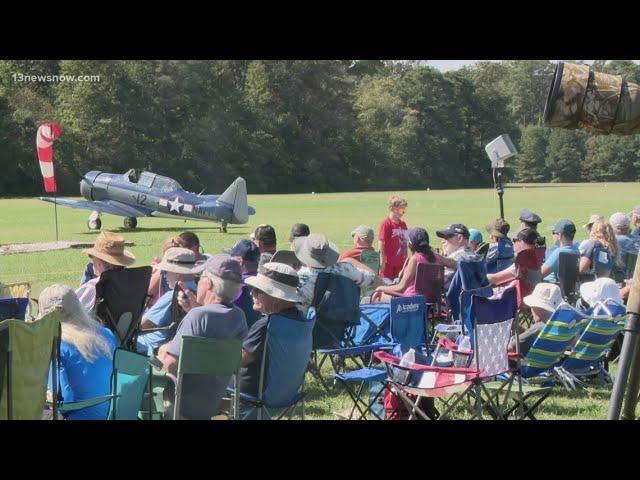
left=0, top=60, right=640, bottom=195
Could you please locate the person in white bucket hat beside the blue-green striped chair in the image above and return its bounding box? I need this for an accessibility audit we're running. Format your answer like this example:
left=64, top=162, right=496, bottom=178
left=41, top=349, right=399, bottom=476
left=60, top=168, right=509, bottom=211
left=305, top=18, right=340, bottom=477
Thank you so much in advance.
left=508, top=283, right=562, bottom=355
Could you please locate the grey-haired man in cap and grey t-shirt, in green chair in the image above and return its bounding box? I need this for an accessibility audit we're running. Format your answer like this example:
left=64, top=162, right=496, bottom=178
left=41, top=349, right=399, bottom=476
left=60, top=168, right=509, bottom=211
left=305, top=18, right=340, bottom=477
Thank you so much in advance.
left=158, top=255, right=247, bottom=420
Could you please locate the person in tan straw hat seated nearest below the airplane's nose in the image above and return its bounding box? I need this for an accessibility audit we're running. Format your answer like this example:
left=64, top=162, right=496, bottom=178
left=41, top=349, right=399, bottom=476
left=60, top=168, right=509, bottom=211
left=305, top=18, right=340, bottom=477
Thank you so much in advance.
left=76, top=230, right=136, bottom=311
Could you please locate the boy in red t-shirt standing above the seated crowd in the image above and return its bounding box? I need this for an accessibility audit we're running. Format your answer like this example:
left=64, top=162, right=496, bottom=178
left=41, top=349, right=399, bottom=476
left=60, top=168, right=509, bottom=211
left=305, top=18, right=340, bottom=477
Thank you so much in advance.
left=378, top=195, right=408, bottom=280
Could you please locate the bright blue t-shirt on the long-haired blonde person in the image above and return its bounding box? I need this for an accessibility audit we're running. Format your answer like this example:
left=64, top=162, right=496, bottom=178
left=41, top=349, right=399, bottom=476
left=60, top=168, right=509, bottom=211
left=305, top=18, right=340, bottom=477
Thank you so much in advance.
left=48, top=327, right=117, bottom=420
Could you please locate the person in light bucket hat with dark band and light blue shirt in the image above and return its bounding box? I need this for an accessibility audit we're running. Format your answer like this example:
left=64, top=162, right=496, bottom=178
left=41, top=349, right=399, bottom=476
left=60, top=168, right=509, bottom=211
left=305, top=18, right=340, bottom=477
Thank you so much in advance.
left=137, top=247, right=197, bottom=353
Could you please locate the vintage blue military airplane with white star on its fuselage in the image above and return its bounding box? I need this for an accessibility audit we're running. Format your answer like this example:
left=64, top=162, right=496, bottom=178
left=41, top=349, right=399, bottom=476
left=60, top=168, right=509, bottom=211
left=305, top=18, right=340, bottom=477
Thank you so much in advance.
left=40, top=169, right=256, bottom=232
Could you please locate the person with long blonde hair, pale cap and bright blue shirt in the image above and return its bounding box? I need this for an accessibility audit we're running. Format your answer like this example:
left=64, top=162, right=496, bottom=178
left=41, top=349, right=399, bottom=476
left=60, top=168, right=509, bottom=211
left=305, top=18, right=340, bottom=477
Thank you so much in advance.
left=38, top=284, right=116, bottom=420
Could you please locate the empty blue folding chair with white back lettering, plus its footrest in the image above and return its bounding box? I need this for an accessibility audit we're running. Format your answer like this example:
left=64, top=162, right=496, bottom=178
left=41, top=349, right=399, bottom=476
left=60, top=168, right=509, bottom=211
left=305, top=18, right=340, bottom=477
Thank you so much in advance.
left=330, top=295, right=428, bottom=420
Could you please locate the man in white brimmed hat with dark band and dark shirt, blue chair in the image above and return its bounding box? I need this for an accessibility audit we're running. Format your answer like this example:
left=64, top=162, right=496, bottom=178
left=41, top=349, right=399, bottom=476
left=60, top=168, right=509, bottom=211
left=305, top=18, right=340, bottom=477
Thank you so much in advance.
left=239, top=262, right=306, bottom=395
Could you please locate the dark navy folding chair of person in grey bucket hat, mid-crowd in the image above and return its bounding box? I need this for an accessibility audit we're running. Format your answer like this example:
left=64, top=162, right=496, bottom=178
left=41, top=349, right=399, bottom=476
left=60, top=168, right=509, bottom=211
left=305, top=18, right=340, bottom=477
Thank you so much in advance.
left=308, top=272, right=363, bottom=390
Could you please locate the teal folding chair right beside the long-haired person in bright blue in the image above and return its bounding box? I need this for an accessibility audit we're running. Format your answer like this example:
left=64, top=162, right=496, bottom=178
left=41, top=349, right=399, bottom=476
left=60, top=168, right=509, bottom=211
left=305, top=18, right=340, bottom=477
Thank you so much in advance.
left=58, top=348, right=150, bottom=420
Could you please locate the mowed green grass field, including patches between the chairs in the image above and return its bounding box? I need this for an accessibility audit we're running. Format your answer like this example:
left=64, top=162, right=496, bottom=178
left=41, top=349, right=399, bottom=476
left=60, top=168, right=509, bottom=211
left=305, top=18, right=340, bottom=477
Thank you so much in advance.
left=0, top=183, right=640, bottom=419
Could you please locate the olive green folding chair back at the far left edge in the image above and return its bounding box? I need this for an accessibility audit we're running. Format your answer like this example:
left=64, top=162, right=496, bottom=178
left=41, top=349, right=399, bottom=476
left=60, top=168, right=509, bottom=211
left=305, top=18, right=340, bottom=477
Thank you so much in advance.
left=0, top=309, right=61, bottom=420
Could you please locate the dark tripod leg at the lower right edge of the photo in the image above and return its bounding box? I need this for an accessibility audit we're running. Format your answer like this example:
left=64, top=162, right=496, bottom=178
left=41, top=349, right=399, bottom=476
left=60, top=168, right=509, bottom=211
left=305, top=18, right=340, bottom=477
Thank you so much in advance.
left=607, top=255, right=640, bottom=420
